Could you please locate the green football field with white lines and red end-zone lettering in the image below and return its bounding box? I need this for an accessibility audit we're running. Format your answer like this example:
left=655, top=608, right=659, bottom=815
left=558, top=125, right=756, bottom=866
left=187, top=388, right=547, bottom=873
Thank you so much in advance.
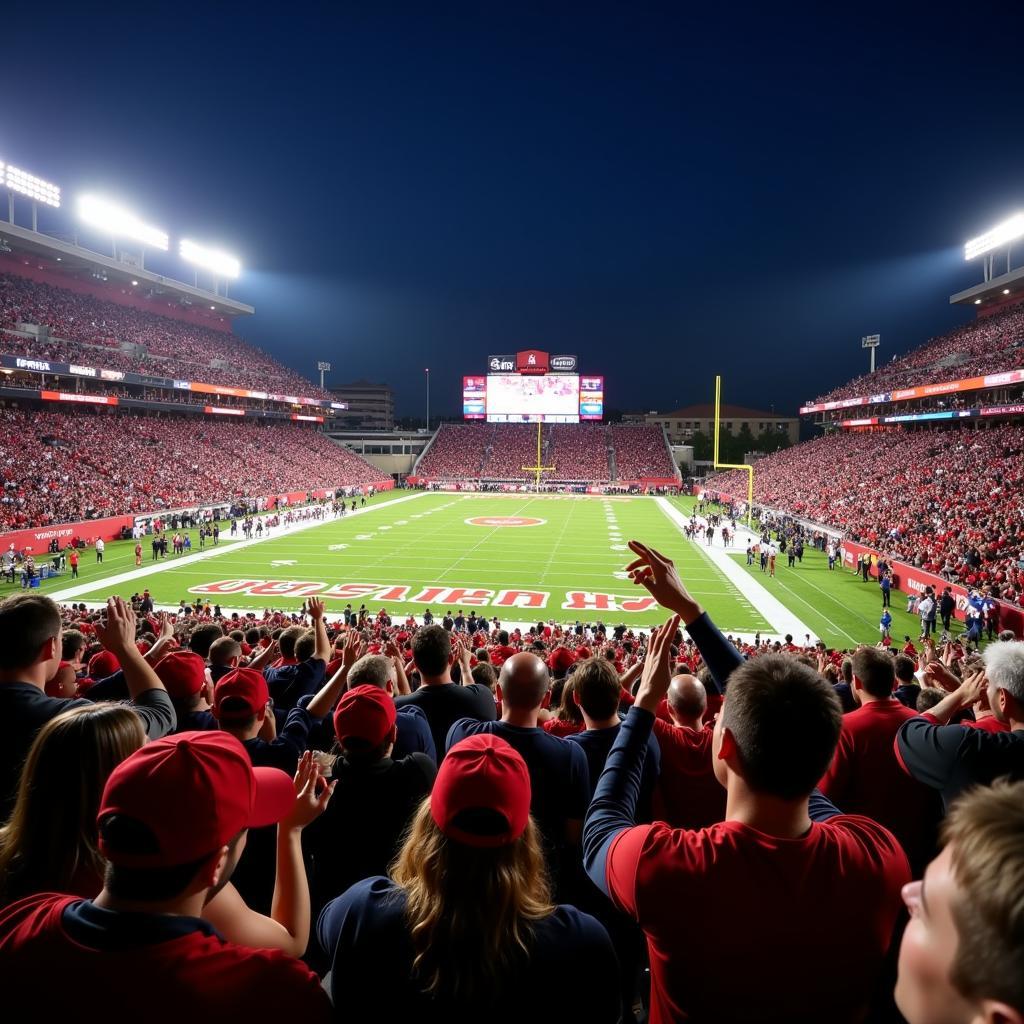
left=9, top=492, right=937, bottom=647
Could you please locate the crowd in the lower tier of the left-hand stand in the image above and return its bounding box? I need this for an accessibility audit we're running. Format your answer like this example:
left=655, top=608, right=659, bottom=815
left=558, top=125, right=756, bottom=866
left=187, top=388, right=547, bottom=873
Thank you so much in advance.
left=0, top=409, right=381, bottom=529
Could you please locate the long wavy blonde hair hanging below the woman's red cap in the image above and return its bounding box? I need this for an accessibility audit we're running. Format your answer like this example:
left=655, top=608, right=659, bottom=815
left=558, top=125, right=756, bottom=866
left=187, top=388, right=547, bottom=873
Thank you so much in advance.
left=391, top=797, right=555, bottom=1005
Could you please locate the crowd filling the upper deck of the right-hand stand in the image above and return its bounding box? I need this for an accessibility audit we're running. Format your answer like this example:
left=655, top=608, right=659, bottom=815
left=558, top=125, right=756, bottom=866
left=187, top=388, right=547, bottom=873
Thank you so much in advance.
left=814, top=306, right=1024, bottom=403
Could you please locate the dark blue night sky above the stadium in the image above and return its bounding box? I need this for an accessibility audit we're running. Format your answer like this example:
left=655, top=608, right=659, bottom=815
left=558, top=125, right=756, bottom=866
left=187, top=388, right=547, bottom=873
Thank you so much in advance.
left=0, top=2, right=1024, bottom=414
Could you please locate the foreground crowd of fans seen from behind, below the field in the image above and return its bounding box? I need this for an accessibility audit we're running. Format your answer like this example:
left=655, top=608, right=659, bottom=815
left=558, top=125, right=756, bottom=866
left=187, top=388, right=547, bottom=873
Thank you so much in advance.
left=0, top=542, right=1024, bottom=1024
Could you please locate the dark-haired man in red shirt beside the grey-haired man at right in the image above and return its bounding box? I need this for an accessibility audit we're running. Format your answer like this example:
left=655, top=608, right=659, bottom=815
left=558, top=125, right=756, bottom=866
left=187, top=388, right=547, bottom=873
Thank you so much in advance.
left=819, top=647, right=942, bottom=878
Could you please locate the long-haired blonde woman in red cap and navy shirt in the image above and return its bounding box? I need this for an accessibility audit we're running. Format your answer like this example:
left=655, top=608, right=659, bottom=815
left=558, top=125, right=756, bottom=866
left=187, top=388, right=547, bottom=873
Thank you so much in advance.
left=317, top=733, right=620, bottom=1024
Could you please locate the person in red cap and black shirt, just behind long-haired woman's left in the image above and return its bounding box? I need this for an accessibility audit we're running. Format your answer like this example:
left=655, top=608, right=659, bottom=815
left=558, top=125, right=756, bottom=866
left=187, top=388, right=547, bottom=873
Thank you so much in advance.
left=304, top=688, right=437, bottom=908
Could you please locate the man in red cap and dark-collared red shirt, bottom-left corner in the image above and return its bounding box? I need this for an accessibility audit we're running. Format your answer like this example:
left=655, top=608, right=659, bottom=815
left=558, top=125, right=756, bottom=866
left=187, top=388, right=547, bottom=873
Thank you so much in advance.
left=0, top=732, right=330, bottom=1024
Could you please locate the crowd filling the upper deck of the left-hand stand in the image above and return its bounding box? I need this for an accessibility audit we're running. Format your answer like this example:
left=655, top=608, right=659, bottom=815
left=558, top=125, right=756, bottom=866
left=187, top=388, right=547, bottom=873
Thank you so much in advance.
left=0, top=273, right=331, bottom=399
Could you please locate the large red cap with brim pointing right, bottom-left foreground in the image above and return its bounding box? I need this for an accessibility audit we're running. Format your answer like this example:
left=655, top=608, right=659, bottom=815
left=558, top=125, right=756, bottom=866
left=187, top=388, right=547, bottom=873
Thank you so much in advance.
left=96, top=731, right=295, bottom=867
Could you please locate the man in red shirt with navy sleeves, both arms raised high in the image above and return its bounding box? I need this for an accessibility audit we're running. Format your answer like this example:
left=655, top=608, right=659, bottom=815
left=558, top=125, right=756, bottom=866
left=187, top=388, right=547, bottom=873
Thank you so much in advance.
left=584, top=541, right=910, bottom=1024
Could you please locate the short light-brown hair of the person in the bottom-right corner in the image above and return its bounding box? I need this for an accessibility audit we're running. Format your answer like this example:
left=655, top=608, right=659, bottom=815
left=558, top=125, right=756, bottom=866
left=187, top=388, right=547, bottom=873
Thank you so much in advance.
left=943, top=779, right=1024, bottom=1011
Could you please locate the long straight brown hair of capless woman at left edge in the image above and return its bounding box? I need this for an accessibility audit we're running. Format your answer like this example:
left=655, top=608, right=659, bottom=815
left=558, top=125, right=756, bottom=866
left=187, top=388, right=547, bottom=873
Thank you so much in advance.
left=0, top=703, right=145, bottom=903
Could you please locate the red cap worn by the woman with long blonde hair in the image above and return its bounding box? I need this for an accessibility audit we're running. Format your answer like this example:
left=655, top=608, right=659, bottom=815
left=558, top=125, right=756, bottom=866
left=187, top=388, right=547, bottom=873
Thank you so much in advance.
left=430, top=732, right=530, bottom=848
